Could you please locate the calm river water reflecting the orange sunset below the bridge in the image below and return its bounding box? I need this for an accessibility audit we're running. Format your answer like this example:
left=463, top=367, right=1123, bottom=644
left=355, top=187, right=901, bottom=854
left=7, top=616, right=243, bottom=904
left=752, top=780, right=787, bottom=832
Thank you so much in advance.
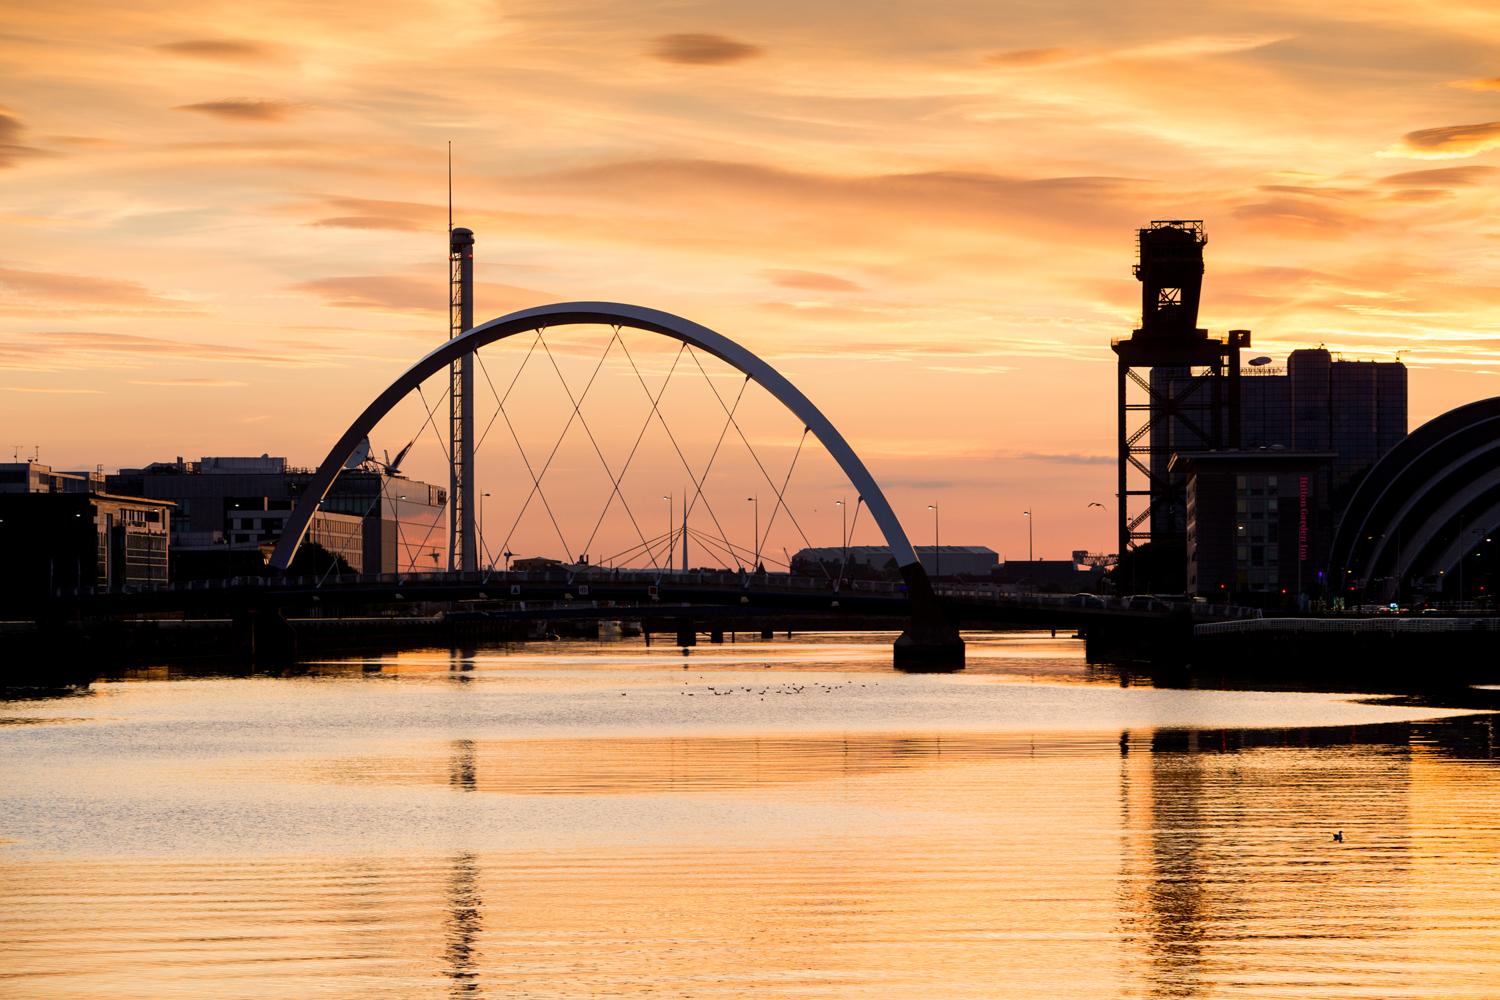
left=0, top=636, right=1500, bottom=1000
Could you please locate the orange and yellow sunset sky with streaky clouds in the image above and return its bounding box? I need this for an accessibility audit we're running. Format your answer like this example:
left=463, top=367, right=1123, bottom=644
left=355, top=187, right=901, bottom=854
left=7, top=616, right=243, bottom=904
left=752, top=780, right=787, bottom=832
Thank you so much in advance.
left=0, top=0, right=1500, bottom=558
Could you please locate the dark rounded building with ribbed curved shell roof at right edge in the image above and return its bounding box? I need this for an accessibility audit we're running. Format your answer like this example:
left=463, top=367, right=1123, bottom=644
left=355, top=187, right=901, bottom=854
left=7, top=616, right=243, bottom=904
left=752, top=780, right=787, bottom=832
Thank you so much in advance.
left=1329, top=396, right=1500, bottom=598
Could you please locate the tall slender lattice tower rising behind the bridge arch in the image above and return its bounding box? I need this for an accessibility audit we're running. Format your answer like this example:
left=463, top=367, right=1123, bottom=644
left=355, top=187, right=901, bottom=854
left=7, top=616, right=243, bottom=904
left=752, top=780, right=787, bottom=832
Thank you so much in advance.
left=449, top=228, right=479, bottom=573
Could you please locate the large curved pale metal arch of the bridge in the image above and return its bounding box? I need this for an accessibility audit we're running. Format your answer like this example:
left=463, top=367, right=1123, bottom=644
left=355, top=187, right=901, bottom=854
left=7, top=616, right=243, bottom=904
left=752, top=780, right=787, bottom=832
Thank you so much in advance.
left=270, top=301, right=920, bottom=571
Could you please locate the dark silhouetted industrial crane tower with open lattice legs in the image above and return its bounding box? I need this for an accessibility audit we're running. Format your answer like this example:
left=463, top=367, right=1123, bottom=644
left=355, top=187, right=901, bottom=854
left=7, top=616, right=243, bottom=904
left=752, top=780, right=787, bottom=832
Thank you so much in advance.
left=1110, top=219, right=1250, bottom=556
